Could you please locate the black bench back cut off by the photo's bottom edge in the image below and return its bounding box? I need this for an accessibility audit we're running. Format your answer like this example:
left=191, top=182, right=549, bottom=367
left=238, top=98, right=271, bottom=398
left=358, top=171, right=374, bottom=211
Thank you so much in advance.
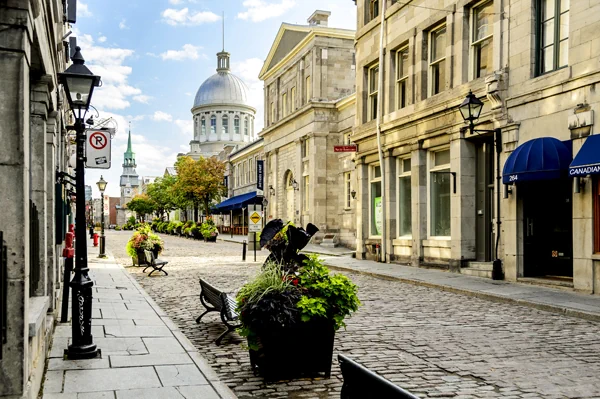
left=338, top=354, right=419, bottom=399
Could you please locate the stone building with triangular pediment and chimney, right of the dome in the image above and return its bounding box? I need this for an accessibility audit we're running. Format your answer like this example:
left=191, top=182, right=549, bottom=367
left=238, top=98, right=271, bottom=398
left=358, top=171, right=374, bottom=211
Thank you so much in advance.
left=259, top=11, right=355, bottom=246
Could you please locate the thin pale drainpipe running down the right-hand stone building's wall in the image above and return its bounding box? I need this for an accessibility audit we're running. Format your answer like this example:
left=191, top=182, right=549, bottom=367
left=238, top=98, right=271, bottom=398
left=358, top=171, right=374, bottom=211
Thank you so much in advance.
left=376, top=0, right=387, bottom=263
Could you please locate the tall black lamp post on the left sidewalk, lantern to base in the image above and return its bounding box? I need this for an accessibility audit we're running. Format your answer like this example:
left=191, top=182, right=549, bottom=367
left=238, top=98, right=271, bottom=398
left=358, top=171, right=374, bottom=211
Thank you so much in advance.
left=58, top=47, right=100, bottom=359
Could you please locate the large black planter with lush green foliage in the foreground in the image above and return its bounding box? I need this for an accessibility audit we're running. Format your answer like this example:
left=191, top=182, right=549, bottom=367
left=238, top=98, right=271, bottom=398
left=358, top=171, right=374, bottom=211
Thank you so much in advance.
left=237, top=220, right=360, bottom=381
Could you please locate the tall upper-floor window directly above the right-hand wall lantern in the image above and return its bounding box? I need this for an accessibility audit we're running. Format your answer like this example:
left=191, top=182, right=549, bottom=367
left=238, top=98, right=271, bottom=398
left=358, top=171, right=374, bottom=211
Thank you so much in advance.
left=471, top=1, right=494, bottom=78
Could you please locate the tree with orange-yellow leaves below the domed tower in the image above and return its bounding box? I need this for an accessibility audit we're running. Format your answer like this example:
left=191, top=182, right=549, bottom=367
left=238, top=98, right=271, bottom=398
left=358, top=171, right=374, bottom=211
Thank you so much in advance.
left=175, top=157, right=226, bottom=221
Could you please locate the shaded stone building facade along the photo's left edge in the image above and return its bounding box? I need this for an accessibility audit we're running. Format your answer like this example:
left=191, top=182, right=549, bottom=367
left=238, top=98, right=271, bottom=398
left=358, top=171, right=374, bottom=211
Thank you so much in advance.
left=0, top=0, right=72, bottom=398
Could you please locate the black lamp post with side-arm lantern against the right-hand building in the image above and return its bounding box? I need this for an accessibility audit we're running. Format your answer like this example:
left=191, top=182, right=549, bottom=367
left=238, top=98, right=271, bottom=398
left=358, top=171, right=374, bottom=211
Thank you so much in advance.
left=458, top=91, right=504, bottom=280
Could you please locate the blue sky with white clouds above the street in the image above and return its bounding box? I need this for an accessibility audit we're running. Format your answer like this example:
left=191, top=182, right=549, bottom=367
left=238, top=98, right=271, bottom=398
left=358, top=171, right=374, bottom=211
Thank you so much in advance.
left=78, top=0, right=356, bottom=197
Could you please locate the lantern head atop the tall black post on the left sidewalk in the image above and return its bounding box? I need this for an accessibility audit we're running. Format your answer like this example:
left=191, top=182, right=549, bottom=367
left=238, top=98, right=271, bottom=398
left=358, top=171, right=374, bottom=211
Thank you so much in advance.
left=58, top=46, right=100, bottom=118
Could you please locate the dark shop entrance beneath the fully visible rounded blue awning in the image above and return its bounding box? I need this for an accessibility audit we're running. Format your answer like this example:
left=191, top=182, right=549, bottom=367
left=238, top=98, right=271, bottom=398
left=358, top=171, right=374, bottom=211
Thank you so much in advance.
left=517, top=178, right=573, bottom=278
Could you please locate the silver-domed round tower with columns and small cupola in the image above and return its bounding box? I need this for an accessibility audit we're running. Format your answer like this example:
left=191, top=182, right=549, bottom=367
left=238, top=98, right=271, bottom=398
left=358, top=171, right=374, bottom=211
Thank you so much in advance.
left=187, top=50, right=256, bottom=159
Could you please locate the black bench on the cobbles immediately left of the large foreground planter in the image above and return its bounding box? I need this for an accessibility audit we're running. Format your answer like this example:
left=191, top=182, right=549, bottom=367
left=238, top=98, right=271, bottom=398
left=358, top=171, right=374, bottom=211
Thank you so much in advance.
left=196, top=279, right=240, bottom=345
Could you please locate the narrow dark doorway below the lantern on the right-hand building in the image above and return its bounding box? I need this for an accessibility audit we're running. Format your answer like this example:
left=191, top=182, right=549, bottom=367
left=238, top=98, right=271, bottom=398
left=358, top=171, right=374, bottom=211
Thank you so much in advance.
left=475, top=139, right=495, bottom=262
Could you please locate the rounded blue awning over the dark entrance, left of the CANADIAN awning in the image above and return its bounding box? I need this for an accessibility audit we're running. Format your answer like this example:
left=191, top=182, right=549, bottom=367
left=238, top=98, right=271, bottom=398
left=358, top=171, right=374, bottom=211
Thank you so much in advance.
left=502, top=137, right=572, bottom=184
